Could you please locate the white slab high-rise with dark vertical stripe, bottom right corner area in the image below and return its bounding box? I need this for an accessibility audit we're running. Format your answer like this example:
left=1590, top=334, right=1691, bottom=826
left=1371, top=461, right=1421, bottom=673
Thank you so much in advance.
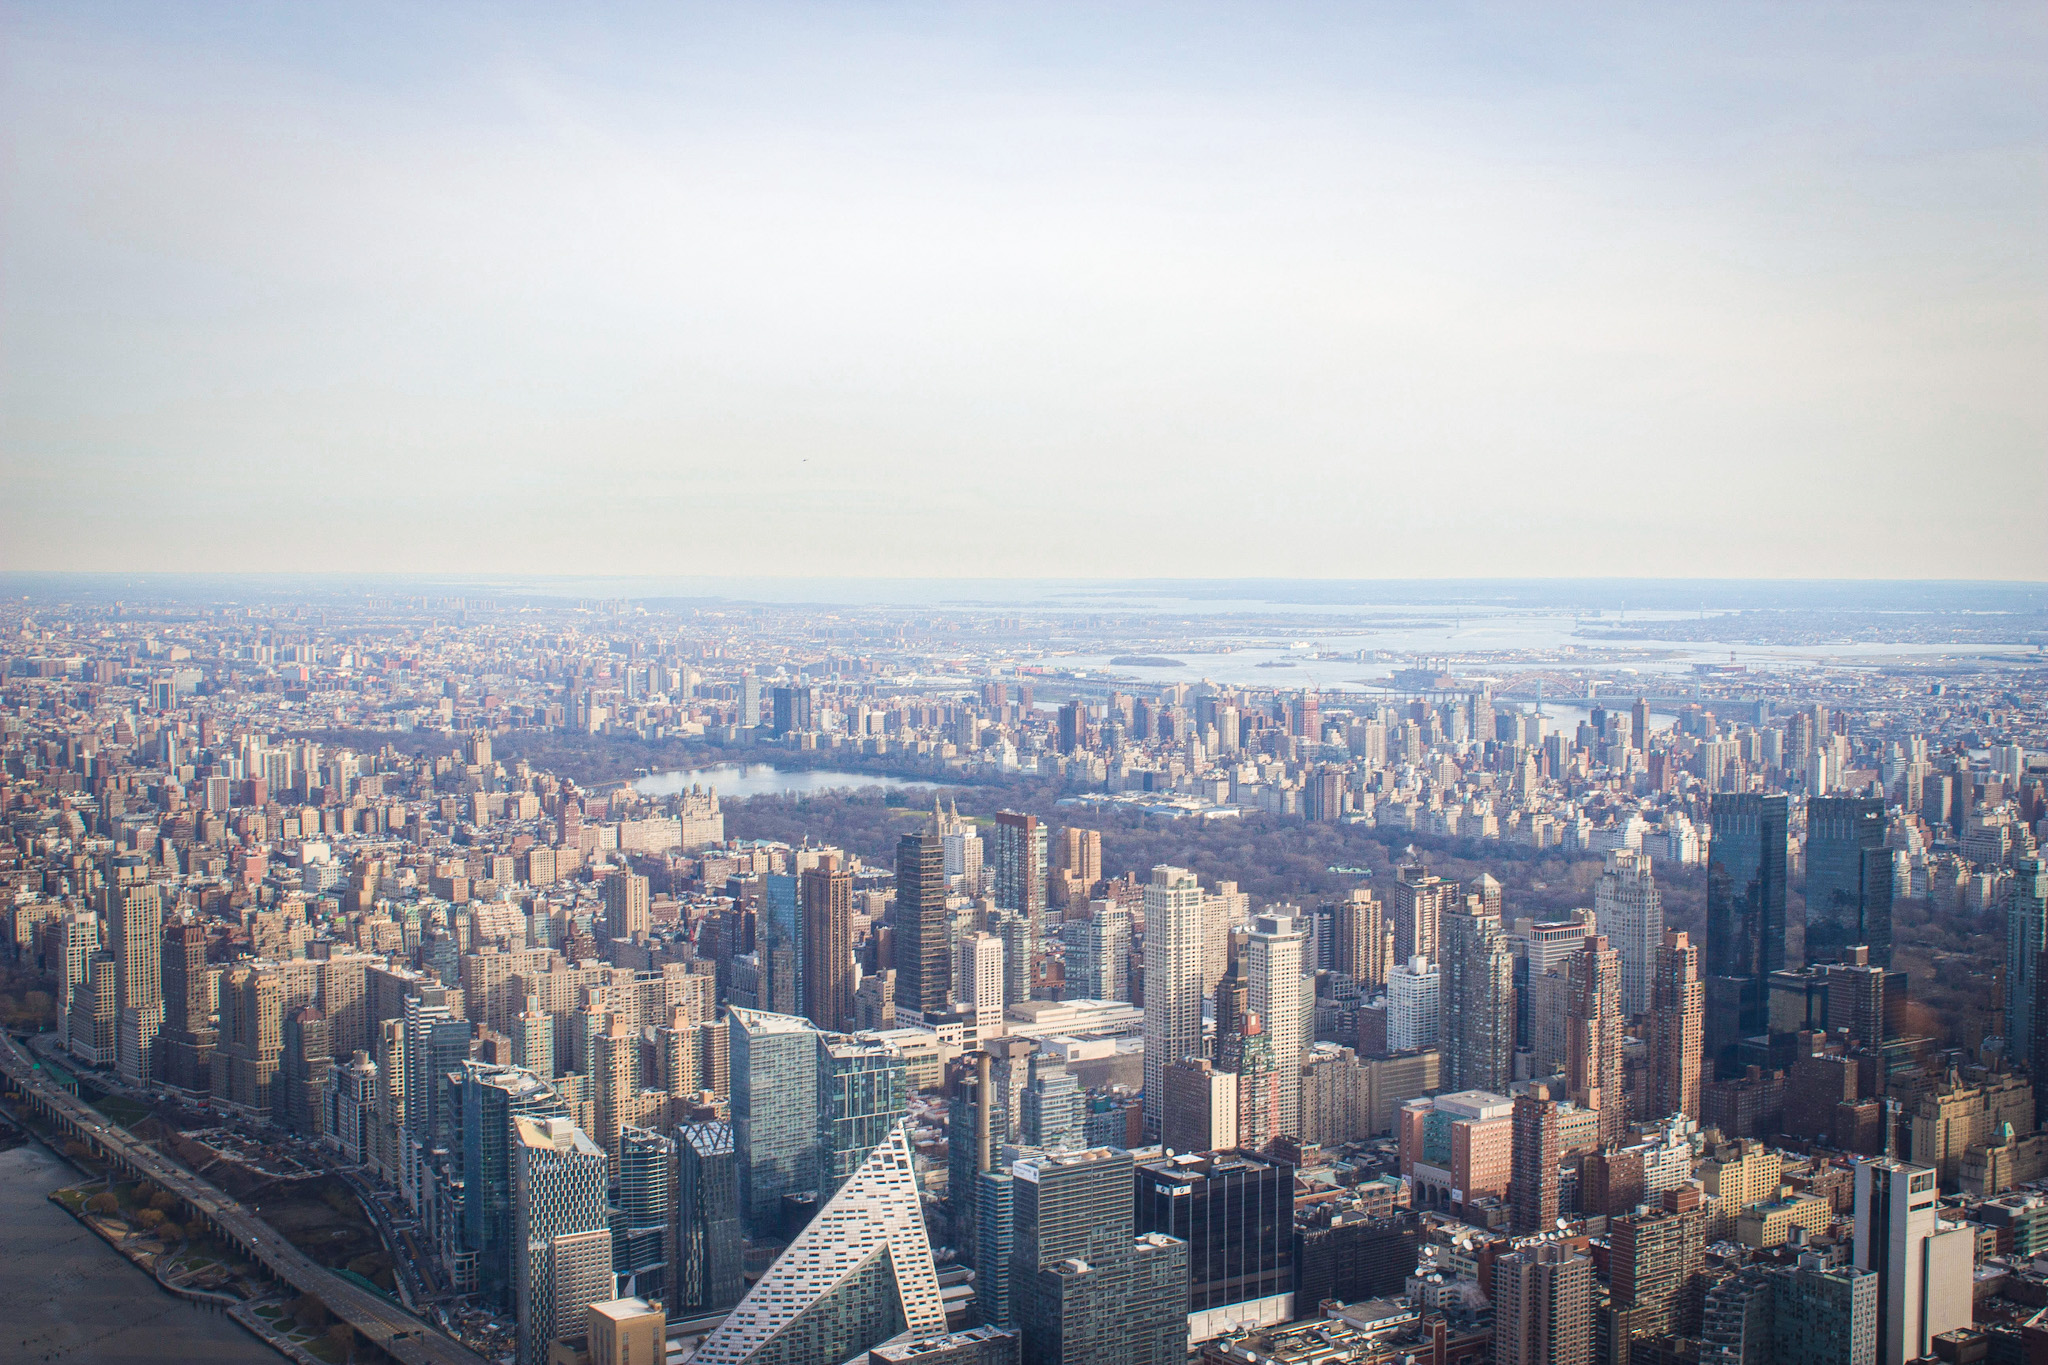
left=1855, top=1156, right=1976, bottom=1365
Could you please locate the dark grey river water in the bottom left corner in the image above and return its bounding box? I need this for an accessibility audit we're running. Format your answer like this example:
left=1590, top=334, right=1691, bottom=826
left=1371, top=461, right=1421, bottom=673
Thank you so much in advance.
left=0, top=1142, right=283, bottom=1365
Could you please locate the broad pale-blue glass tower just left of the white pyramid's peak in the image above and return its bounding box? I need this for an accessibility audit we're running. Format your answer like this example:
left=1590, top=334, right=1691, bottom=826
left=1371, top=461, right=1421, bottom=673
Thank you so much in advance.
left=731, top=1007, right=821, bottom=1238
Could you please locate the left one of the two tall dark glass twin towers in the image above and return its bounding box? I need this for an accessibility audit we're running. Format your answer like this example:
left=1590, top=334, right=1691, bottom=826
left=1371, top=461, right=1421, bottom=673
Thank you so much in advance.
left=1706, top=792, right=1790, bottom=1074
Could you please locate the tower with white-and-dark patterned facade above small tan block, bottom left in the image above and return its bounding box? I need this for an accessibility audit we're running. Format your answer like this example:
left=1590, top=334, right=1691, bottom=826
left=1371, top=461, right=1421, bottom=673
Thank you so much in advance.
left=512, top=1117, right=614, bottom=1365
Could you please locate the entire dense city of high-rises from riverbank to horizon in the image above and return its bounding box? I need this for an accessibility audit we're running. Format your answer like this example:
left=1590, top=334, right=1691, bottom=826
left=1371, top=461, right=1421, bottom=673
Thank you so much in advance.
left=0, top=577, right=2048, bottom=1365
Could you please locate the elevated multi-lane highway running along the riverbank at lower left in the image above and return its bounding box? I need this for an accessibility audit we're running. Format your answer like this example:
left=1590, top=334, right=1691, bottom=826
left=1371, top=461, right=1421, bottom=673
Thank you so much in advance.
left=0, top=1033, right=485, bottom=1365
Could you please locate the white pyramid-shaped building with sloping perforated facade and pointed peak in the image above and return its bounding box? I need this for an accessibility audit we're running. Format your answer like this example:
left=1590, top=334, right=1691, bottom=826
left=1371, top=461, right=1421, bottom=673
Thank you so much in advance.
left=690, top=1124, right=946, bottom=1365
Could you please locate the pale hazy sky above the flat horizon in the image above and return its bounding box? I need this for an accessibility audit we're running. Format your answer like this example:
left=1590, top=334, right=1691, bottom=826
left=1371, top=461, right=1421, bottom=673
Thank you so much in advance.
left=0, top=0, right=2048, bottom=579
